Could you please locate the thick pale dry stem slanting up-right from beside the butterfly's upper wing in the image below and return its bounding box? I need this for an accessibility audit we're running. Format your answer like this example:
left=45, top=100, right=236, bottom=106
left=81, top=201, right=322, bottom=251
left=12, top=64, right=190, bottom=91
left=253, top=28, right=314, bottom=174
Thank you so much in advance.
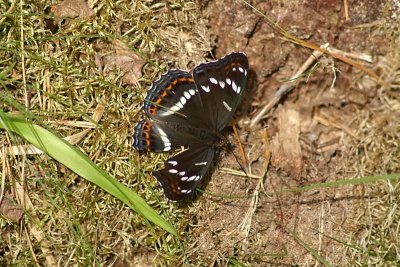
left=250, top=43, right=329, bottom=128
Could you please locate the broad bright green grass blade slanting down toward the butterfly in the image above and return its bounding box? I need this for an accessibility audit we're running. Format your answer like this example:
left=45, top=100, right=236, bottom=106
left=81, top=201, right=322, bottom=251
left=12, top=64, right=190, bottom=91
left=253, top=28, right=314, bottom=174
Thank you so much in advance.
left=0, top=113, right=177, bottom=235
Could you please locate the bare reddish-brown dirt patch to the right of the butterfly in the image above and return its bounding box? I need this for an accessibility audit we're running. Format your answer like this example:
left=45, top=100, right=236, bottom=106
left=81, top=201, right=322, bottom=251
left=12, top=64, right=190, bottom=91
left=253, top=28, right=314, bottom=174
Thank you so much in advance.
left=183, top=1, right=398, bottom=266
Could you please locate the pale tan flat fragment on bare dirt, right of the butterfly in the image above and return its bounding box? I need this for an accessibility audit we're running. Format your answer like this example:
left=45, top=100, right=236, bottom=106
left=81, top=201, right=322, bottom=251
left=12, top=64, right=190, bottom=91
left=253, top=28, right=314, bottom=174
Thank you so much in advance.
left=271, top=106, right=303, bottom=177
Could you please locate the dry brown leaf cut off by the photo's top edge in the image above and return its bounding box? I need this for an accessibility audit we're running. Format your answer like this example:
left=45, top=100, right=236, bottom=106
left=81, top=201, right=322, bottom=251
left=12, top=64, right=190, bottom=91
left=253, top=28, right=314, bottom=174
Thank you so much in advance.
left=51, top=0, right=94, bottom=19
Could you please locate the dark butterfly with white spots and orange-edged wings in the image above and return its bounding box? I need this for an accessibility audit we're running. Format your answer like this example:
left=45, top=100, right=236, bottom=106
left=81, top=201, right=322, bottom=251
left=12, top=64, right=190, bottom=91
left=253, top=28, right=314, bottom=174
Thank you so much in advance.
left=133, top=52, right=249, bottom=201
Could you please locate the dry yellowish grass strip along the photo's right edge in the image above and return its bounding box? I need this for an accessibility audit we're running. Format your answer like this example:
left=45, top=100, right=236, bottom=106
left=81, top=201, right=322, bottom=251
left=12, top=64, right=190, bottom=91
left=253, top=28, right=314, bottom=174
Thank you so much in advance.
left=350, top=49, right=400, bottom=265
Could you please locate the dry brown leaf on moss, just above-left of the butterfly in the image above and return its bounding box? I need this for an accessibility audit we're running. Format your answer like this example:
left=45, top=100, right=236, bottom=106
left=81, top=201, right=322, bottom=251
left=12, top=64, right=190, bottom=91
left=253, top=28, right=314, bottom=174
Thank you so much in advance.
left=98, top=39, right=146, bottom=84
